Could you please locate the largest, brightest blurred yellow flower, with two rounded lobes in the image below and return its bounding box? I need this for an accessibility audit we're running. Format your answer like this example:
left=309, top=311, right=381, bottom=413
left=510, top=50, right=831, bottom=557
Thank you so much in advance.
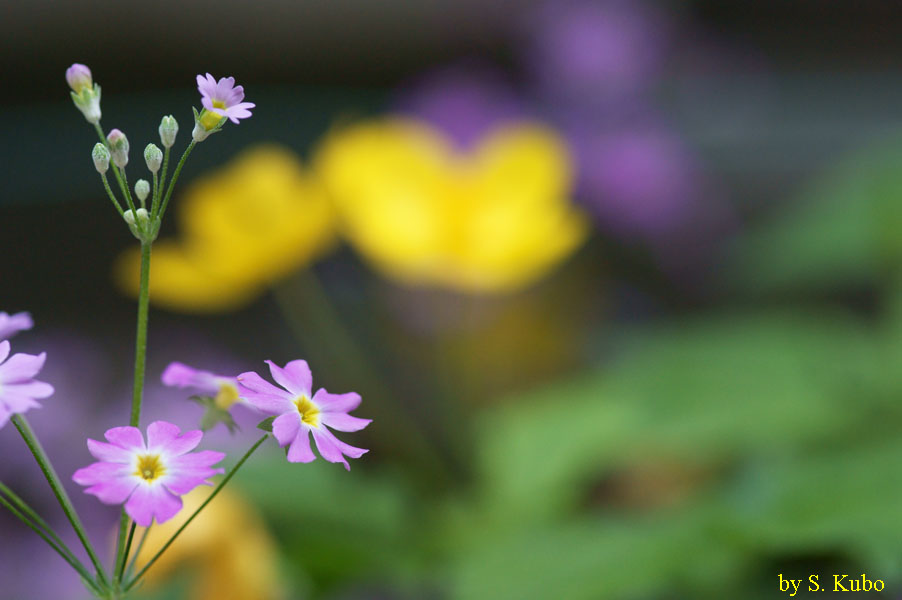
left=315, top=119, right=588, bottom=293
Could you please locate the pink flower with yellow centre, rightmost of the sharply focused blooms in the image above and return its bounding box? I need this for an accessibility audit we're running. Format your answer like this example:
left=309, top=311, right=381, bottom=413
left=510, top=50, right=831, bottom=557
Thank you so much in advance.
left=238, top=360, right=372, bottom=470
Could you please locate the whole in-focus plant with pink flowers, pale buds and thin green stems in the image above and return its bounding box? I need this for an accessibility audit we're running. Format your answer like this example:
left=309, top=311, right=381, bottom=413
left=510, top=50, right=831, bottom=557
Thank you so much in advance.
left=0, top=64, right=369, bottom=600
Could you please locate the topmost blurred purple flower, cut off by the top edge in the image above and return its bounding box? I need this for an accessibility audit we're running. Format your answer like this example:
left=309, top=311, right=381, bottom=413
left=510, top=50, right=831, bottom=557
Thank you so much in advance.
left=526, top=0, right=670, bottom=106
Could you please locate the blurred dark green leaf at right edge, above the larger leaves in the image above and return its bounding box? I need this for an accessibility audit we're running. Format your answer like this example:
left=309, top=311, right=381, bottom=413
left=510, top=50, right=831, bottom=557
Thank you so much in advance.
left=724, top=140, right=902, bottom=293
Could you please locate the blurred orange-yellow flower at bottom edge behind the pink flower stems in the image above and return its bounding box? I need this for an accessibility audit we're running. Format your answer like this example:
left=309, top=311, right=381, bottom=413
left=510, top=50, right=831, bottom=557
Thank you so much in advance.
left=135, top=486, right=282, bottom=600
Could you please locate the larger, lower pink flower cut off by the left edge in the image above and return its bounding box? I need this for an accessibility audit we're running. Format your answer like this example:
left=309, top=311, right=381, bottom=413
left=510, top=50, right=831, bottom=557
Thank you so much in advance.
left=0, top=341, right=53, bottom=428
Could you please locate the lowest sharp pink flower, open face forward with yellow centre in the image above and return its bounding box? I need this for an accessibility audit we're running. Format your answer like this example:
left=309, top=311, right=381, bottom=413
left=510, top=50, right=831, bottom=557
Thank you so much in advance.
left=72, top=421, right=225, bottom=527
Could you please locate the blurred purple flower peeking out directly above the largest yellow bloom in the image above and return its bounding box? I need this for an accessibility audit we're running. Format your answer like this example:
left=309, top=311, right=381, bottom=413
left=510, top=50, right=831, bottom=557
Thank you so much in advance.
left=397, top=65, right=527, bottom=149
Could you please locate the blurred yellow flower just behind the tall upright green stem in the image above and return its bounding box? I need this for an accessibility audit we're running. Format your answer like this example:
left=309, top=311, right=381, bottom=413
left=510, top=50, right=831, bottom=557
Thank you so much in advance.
left=114, top=146, right=336, bottom=312
